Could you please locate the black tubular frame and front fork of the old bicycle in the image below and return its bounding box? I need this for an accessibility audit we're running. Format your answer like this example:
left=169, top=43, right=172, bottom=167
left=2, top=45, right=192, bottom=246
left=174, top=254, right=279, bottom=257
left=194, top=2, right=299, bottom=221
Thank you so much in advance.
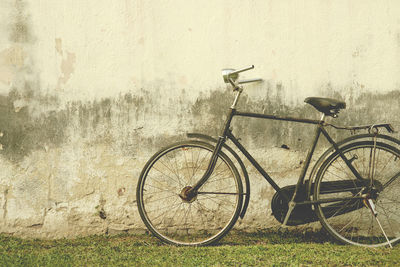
left=191, top=108, right=362, bottom=205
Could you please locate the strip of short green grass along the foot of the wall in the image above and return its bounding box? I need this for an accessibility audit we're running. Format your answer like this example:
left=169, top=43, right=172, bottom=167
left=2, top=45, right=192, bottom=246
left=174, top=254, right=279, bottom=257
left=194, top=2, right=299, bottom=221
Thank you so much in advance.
left=0, top=231, right=400, bottom=266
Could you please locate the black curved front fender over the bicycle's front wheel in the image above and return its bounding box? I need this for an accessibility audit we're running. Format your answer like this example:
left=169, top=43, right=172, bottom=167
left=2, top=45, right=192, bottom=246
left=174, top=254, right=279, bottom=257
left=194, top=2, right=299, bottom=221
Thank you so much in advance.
left=186, top=133, right=250, bottom=219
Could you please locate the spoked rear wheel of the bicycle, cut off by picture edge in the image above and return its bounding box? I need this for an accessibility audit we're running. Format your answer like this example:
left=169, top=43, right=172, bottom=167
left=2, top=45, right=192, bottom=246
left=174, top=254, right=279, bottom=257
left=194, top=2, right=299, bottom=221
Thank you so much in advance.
left=313, top=141, right=400, bottom=247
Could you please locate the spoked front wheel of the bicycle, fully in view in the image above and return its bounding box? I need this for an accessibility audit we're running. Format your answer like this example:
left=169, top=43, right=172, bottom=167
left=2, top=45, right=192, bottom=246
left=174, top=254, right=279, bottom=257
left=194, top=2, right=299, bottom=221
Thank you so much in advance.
left=136, top=141, right=243, bottom=246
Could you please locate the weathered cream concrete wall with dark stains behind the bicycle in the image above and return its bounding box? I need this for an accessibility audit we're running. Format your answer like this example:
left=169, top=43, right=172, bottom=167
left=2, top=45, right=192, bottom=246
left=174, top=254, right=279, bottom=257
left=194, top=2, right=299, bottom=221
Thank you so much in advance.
left=0, top=0, right=400, bottom=238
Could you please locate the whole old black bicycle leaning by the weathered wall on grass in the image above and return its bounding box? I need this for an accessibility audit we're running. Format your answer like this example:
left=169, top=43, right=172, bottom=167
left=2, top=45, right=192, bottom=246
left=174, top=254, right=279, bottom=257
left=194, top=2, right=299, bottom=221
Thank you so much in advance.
left=137, top=66, right=400, bottom=247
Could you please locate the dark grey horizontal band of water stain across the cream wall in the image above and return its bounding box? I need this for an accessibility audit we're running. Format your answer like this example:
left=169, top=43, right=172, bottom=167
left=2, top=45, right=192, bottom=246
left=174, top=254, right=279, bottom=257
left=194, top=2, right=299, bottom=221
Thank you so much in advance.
left=0, top=86, right=400, bottom=160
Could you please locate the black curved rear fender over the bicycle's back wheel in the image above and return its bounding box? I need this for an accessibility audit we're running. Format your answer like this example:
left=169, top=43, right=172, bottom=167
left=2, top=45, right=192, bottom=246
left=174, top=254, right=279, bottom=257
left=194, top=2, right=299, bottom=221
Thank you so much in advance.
left=306, top=134, right=400, bottom=198
